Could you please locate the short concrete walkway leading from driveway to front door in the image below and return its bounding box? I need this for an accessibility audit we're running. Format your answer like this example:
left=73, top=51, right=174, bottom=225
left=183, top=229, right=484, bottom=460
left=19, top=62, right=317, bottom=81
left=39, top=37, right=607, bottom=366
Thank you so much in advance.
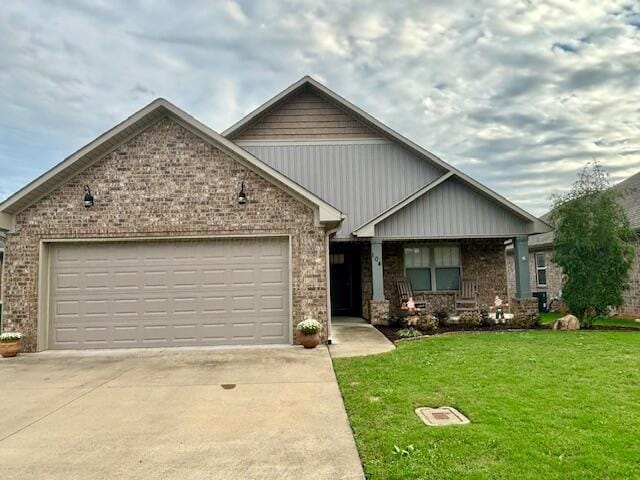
left=329, top=317, right=396, bottom=358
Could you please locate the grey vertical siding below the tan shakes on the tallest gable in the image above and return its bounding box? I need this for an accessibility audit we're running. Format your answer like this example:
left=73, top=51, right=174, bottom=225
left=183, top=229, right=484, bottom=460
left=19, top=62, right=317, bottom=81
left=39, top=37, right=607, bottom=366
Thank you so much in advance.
left=241, top=141, right=445, bottom=238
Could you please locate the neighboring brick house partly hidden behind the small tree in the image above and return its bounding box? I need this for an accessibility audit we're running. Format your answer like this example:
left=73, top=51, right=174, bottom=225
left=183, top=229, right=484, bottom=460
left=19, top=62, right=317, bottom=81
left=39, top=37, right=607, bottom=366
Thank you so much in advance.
left=506, top=172, right=640, bottom=316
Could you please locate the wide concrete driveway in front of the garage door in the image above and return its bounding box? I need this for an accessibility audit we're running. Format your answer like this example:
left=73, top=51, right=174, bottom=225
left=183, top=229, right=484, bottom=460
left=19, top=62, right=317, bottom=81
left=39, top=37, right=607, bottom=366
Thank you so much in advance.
left=0, top=347, right=364, bottom=480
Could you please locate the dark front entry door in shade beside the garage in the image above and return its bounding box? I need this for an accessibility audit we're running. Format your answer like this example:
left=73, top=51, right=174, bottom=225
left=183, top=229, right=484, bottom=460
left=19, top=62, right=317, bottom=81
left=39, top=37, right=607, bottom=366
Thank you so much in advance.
left=329, top=247, right=362, bottom=316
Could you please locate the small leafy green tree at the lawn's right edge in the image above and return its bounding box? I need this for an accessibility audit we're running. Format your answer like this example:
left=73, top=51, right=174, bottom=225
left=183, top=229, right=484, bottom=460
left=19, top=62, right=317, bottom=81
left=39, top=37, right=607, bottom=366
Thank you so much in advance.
left=551, top=162, right=635, bottom=328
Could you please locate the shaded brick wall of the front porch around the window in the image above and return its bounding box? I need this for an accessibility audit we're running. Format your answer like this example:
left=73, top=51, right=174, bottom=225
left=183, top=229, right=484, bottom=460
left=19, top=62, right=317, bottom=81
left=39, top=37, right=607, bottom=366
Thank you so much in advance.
left=361, top=239, right=508, bottom=318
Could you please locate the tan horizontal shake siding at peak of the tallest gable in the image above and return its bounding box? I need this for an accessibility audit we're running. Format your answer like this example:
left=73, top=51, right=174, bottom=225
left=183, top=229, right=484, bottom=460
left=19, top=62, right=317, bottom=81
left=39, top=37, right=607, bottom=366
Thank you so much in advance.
left=231, top=92, right=382, bottom=141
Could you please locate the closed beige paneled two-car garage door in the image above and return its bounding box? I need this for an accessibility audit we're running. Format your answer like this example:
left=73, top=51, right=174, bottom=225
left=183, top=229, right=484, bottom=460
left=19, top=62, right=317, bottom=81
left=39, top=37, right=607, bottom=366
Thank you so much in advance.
left=49, top=238, right=289, bottom=349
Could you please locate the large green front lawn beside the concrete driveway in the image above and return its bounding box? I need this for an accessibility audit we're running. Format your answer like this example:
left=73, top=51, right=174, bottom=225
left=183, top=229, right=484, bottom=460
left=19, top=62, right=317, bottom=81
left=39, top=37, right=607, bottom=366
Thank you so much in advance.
left=334, top=331, right=640, bottom=479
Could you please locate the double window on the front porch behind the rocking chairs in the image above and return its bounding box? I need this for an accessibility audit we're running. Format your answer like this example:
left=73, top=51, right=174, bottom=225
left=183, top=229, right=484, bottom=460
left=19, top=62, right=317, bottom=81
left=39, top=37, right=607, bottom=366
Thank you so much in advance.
left=404, top=245, right=461, bottom=292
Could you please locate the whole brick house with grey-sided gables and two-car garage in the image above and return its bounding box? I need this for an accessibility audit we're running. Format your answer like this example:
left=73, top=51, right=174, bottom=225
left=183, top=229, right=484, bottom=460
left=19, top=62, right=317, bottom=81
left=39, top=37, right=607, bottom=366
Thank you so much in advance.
left=0, top=77, right=548, bottom=350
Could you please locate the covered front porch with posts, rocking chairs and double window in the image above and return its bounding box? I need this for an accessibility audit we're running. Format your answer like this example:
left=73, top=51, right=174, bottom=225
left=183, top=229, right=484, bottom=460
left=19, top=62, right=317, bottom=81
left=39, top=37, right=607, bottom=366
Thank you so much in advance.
left=330, top=236, right=531, bottom=325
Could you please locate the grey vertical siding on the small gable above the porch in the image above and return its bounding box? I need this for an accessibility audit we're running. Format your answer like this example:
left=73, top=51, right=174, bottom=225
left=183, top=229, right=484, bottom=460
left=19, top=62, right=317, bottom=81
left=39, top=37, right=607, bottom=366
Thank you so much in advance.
left=375, top=178, right=528, bottom=238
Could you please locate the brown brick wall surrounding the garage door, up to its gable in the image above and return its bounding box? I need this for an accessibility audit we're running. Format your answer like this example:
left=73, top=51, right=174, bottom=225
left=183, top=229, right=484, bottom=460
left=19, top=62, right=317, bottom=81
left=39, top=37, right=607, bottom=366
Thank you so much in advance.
left=4, top=118, right=327, bottom=351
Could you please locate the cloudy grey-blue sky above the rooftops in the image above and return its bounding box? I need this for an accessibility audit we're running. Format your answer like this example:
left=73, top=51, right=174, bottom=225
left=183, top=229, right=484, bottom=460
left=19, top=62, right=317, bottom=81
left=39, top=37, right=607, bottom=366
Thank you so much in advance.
left=0, top=0, right=640, bottom=214
